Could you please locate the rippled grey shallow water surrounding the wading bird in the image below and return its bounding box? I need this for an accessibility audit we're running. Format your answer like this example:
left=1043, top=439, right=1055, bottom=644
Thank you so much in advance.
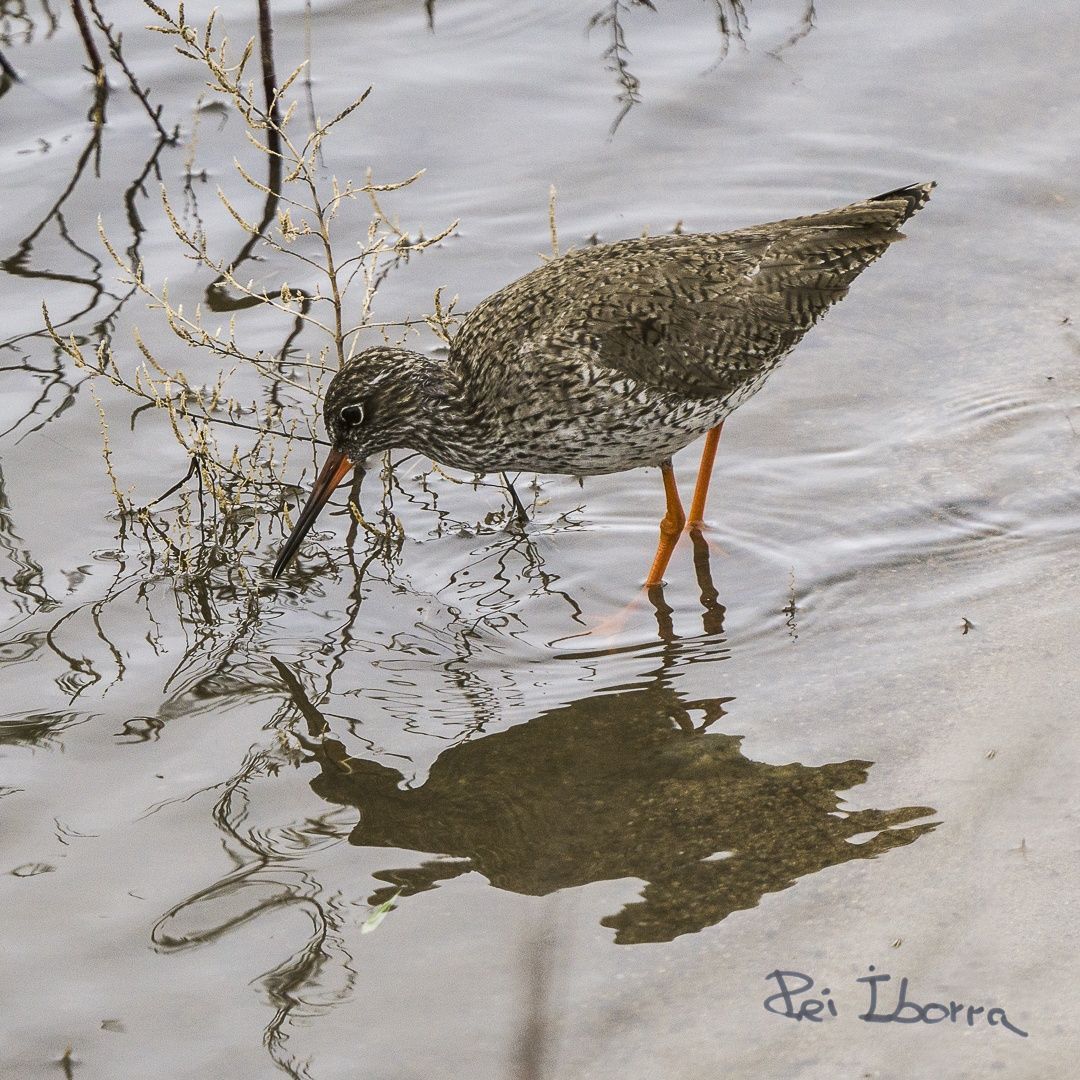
left=0, top=0, right=1080, bottom=1080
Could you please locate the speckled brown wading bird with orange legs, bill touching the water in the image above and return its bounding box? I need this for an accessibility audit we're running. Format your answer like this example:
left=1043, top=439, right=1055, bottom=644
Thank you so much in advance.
left=273, top=181, right=934, bottom=586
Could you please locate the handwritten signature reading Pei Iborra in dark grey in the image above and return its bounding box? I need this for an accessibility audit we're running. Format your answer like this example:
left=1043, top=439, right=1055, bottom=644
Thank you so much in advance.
left=762, top=964, right=1028, bottom=1039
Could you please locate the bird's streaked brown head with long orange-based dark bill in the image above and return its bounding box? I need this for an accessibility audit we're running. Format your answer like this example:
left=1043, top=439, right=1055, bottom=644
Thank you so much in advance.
left=272, top=346, right=432, bottom=578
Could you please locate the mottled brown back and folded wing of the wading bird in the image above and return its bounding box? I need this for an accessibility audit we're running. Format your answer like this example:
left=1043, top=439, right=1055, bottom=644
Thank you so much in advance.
left=453, top=183, right=933, bottom=399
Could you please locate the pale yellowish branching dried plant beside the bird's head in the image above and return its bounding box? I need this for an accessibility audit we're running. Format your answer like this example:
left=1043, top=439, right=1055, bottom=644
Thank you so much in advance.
left=56, top=0, right=458, bottom=588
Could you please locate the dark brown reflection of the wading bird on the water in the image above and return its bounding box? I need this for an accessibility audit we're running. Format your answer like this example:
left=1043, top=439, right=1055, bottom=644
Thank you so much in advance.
left=287, top=570, right=934, bottom=944
